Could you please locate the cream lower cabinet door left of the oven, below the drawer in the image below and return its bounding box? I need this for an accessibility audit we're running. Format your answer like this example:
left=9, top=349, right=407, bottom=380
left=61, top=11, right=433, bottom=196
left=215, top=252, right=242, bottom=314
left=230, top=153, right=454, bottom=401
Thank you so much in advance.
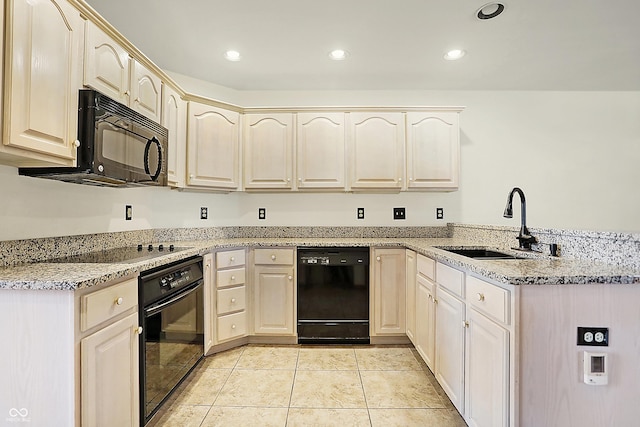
left=80, top=313, right=140, bottom=427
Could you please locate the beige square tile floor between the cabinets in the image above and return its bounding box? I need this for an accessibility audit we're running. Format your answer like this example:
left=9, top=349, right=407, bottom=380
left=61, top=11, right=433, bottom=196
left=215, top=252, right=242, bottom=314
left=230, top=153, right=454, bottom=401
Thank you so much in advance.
left=147, top=345, right=466, bottom=427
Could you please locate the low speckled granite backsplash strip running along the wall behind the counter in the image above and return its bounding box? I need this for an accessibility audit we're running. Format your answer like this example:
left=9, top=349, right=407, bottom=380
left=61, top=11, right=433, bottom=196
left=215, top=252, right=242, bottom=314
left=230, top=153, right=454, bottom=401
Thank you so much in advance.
left=0, top=224, right=640, bottom=268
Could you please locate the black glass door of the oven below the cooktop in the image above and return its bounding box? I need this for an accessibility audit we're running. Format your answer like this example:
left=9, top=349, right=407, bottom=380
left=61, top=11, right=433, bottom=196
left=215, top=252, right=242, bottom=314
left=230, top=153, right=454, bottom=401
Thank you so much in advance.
left=140, top=281, right=204, bottom=425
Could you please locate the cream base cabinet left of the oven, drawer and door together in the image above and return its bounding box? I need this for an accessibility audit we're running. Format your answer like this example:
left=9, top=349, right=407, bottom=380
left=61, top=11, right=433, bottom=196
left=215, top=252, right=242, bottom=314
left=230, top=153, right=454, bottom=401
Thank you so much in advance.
left=78, top=278, right=141, bottom=426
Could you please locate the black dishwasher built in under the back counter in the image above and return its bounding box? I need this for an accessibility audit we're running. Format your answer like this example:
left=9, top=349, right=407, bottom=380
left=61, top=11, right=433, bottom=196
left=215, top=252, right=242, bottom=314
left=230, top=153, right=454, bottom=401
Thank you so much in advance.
left=298, top=247, right=369, bottom=344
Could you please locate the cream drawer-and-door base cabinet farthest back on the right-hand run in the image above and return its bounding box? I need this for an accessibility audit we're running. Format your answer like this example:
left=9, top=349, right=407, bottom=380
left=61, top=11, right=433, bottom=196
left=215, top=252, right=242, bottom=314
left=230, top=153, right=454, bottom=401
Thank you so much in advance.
left=414, top=254, right=436, bottom=372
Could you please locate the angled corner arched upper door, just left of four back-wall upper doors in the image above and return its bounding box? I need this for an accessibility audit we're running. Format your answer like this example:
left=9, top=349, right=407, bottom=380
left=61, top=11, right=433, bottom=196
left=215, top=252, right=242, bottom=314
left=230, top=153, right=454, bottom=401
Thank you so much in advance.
left=187, top=101, right=240, bottom=190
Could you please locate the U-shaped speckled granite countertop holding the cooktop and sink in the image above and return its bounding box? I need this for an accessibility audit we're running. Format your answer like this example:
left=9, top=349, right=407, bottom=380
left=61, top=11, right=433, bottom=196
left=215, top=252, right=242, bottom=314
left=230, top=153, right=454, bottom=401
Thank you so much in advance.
left=0, top=238, right=640, bottom=291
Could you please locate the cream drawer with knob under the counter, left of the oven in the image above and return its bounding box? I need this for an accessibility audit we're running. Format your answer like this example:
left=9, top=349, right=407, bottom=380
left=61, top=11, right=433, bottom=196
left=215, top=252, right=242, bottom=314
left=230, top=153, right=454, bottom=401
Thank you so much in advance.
left=80, top=279, right=138, bottom=332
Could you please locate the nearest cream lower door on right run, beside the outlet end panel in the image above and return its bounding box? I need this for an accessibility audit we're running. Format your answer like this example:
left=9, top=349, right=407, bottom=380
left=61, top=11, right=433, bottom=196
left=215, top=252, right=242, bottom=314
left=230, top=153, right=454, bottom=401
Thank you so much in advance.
left=465, top=309, right=509, bottom=427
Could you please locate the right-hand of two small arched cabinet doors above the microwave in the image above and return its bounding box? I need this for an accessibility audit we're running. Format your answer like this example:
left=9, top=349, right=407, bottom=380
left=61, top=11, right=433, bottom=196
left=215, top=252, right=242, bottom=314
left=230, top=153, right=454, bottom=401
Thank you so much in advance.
left=129, top=60, right=162, bottom=123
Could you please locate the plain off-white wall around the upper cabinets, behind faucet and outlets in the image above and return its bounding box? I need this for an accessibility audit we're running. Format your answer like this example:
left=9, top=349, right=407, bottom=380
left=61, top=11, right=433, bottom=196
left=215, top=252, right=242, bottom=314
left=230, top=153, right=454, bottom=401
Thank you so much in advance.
left=0, top=85, right=640, bottom=240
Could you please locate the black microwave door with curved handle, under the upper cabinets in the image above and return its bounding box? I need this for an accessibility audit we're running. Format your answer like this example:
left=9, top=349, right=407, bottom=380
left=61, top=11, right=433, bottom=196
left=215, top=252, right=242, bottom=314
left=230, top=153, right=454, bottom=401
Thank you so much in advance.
left=94, top=111, right=167, bottom=185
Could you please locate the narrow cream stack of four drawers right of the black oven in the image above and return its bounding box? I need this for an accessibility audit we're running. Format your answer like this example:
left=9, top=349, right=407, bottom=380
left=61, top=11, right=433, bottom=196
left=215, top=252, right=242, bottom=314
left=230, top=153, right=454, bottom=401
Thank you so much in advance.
left=213, top=249, right=247, bottom=344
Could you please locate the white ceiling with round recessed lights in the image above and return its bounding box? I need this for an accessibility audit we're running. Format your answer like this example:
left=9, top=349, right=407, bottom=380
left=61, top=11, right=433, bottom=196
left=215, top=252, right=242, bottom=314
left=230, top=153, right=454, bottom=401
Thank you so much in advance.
left=86, top=0, right=640, bottom=91
